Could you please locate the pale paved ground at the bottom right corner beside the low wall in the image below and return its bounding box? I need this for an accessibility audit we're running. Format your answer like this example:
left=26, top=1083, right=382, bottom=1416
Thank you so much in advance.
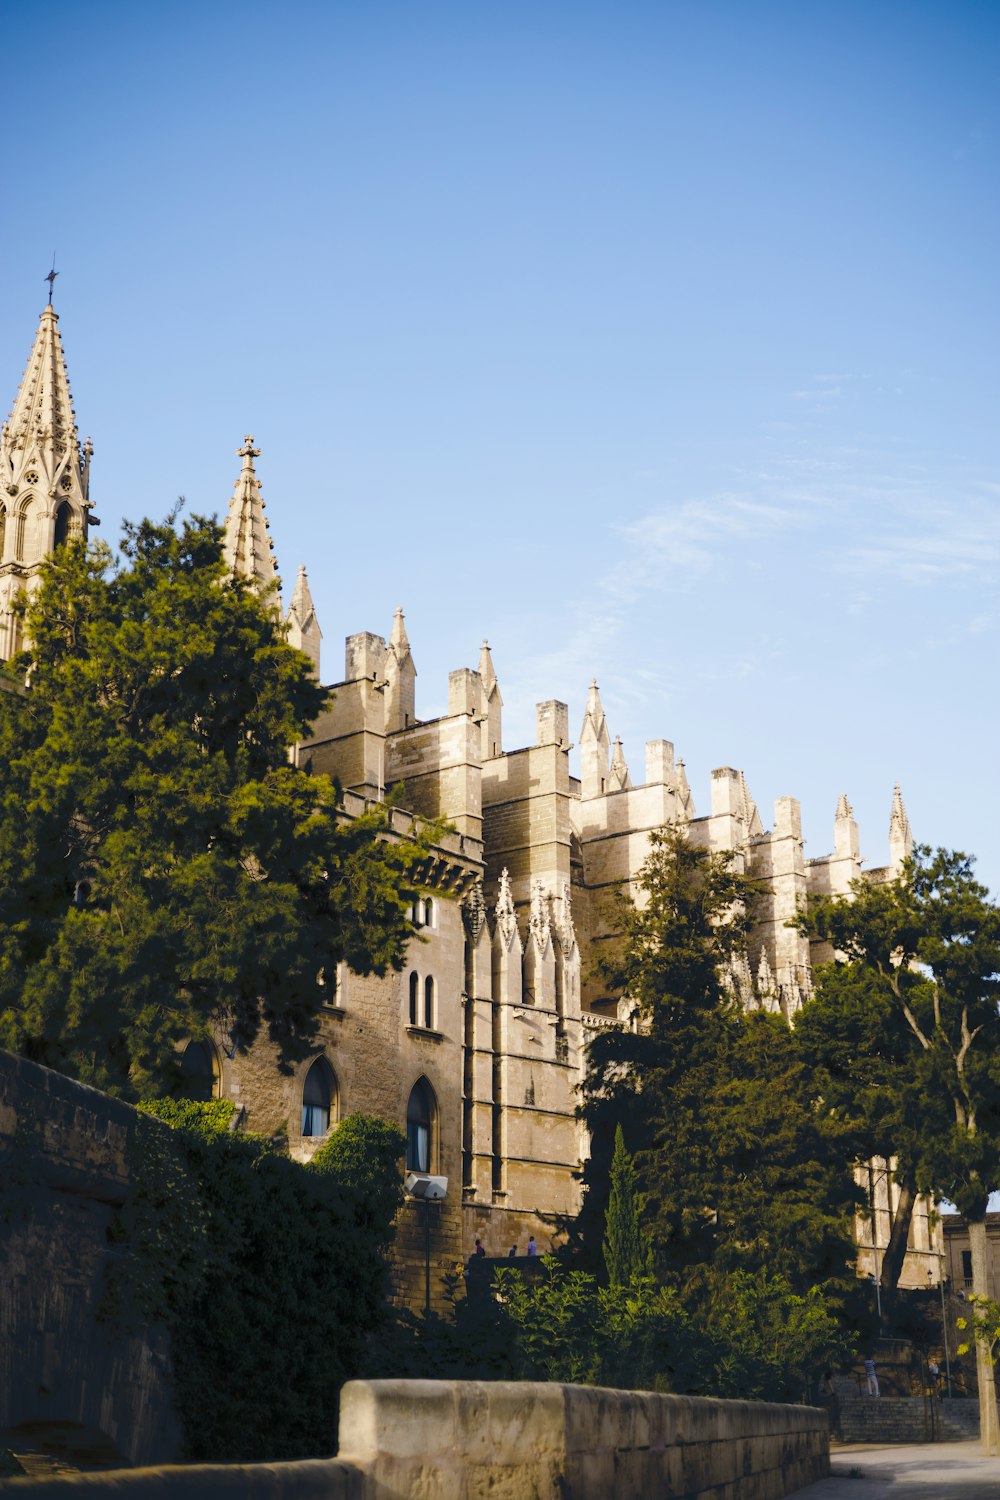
left=795, top=1443, right=1000, bottom=1500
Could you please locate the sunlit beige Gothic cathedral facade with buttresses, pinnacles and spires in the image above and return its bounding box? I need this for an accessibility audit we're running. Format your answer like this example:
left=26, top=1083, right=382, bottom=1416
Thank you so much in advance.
left=0, top=306, right=942, bottom=1298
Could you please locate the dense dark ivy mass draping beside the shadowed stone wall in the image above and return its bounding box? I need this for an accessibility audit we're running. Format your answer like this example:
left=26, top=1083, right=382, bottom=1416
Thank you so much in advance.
left=103, top=1100, right=405, bottom=1461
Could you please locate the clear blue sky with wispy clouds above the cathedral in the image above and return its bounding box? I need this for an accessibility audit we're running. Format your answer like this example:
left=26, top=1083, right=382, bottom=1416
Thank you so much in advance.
left=0, top=0, right=1000, bottom=891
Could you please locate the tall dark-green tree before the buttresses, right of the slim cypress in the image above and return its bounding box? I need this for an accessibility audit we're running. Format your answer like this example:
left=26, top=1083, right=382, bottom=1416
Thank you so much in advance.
left=582, top=828, right=856, bottom=1296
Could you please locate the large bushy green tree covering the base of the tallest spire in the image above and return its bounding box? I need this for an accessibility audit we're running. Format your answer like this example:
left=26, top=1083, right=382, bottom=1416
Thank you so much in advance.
left=0, top=516, right=434, bottom=1098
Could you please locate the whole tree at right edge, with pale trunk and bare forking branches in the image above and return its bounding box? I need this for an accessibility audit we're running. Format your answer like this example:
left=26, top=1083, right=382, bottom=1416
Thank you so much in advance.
left=805, top=846, right=1000, bottom=1451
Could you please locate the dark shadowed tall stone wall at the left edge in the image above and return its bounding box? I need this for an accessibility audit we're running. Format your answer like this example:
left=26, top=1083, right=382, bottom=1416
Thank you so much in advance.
left=0, top=1052, right=178, bottom=1463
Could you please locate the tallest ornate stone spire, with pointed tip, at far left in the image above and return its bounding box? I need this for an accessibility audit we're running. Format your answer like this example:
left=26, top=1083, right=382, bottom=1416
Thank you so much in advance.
left=0, top=302, right=93, bottom=659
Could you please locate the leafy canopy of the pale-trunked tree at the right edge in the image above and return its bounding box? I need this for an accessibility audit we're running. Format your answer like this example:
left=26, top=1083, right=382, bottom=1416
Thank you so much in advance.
left=804, top=846, right=1000, bottom=1218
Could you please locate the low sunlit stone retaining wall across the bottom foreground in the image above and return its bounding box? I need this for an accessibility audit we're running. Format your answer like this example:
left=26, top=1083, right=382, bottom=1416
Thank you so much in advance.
left=0, top=1380, right=829, bottom=1500
